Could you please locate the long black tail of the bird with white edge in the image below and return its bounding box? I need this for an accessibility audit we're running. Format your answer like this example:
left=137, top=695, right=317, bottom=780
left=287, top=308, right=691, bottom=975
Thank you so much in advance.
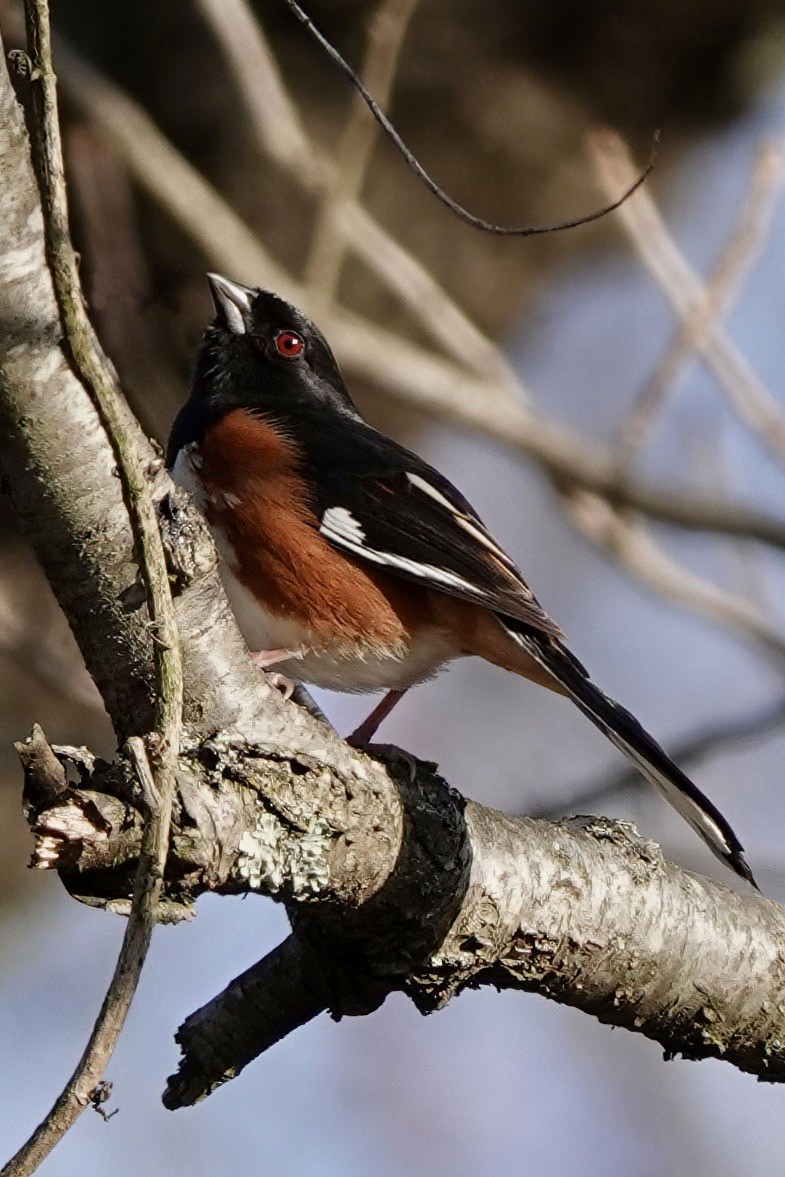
left=499, top=617, right=758, bottom=887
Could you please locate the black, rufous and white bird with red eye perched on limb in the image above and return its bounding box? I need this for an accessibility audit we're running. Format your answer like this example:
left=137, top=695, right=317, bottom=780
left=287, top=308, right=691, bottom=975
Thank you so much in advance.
left=166, top=273, right=757, bottom=886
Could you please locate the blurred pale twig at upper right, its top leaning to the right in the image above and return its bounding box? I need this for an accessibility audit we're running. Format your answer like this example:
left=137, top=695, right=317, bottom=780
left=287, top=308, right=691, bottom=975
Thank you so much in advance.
left=618, top=142, right=785, bottom=472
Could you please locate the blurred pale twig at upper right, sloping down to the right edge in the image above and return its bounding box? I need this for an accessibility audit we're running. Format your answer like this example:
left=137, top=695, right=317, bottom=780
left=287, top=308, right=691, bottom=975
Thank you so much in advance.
left=587, top=132, right=785, bottom=460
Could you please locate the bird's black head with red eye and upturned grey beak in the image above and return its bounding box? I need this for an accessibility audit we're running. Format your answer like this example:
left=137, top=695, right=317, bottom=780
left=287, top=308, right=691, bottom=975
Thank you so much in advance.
left=178, top=274, right=358, bottom=459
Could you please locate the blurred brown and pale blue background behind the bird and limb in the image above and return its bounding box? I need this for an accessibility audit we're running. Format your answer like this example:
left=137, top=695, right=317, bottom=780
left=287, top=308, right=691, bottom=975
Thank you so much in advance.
left=0, top=0, right=785, bottom=1177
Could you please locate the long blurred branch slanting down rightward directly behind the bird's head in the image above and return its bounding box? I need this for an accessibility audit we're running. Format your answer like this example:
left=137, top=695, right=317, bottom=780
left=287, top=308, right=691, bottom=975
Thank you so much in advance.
left=41, top=41, right=785, bottom=550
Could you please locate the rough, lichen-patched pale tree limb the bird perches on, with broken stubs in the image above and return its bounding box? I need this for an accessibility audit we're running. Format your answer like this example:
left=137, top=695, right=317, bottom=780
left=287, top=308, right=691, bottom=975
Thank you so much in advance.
left=0, top=32, right=785, bottom=1106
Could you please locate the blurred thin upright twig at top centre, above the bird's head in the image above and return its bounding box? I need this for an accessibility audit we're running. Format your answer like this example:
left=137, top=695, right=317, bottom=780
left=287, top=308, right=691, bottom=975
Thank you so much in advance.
left=305, top=0, right=419, bottom=302
